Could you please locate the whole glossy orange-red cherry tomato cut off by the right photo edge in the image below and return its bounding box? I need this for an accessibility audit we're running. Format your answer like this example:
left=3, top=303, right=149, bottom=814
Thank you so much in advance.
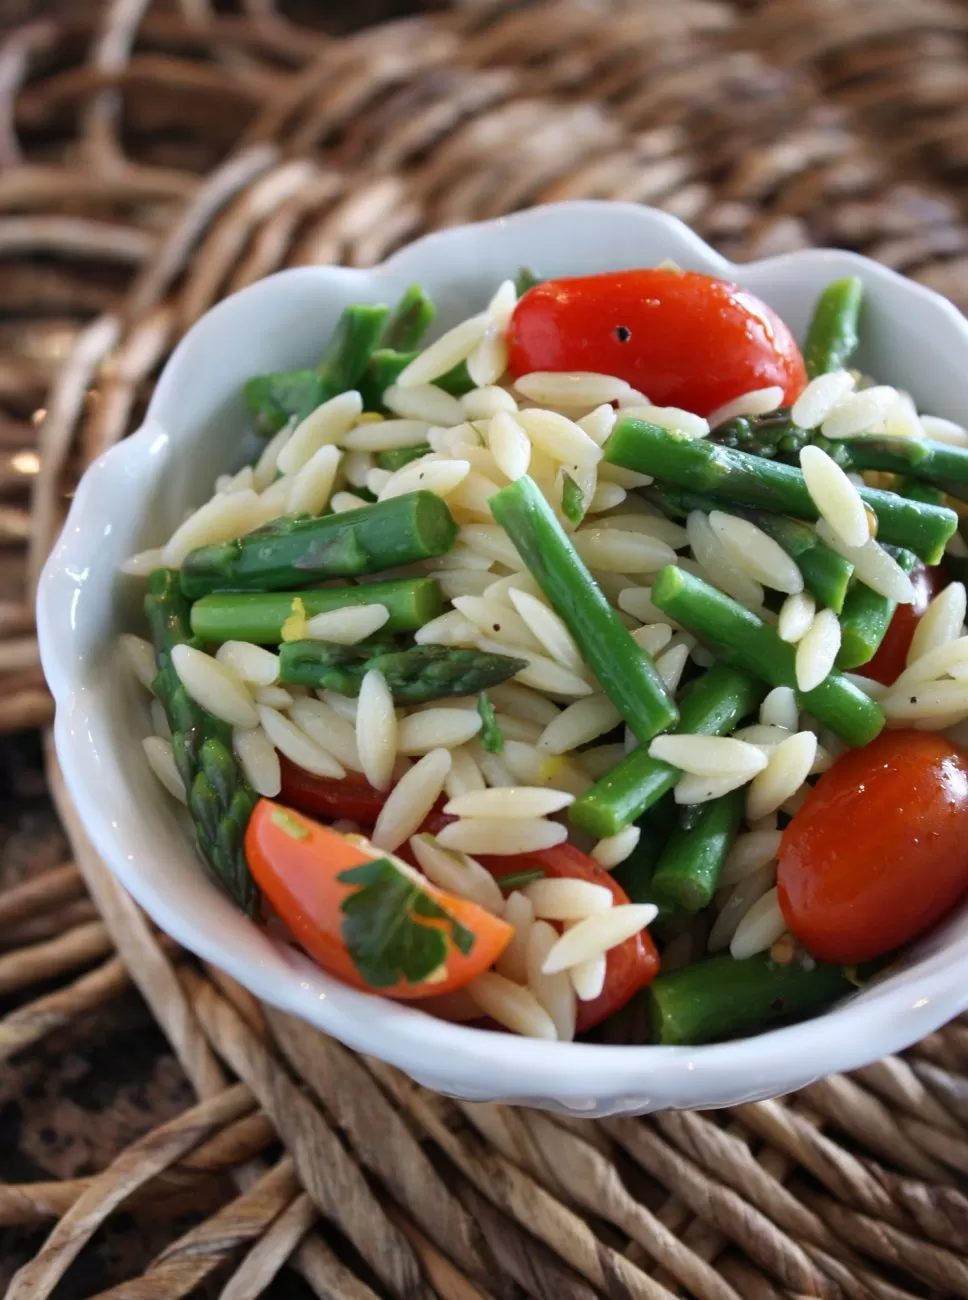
left=777, top=731, right=968, bottom=963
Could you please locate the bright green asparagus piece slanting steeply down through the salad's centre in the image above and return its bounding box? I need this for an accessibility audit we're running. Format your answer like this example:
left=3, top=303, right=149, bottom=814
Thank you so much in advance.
left=490, top=475, right=678, bottom=741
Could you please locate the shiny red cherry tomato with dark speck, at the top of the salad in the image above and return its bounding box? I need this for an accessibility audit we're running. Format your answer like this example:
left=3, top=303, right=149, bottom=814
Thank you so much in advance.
left=508, top=268, right=807, bottom=415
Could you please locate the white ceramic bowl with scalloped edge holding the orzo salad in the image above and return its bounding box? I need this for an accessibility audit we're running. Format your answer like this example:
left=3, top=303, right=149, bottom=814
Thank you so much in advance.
left=38, top=203, right=968, bottom=1115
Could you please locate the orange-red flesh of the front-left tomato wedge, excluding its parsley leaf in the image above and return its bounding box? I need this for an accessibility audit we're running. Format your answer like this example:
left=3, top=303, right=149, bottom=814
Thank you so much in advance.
left=246, top=800, right=513, bottom=998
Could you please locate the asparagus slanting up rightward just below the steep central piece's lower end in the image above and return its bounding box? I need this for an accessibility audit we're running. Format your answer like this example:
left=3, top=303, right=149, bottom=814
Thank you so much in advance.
left=568, top=663, right=767, bottom=839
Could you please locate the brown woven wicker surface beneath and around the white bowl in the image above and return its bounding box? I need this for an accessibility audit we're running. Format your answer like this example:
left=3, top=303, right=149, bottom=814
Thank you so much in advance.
left=0, top=0, right=968, bottom=1300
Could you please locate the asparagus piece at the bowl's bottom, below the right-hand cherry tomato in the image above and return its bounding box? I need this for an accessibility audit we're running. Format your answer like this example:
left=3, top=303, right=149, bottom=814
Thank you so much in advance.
left=648, top=953, right=852, bottom=1045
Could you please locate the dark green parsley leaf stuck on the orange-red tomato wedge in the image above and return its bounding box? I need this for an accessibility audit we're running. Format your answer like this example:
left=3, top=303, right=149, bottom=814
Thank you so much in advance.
left=337, top=858, right=474, bottom=988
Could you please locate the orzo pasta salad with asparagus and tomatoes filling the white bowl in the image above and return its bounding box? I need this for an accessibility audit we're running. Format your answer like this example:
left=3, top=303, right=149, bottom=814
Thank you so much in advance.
left=125, top=264, right=968, bottom=1044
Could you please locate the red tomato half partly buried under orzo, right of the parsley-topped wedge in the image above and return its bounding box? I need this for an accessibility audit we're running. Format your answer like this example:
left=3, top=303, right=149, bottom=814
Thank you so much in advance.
left=478, top=844, right=659, bottom=1034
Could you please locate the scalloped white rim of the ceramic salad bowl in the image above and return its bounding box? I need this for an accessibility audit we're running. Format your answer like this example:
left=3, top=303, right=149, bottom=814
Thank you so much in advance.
left=38, top=200, right=968, bottom=1114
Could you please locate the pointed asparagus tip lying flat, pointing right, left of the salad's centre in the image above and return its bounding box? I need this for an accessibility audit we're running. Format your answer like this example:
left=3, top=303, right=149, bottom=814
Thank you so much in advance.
left=279, top=641, right=528, bottom=705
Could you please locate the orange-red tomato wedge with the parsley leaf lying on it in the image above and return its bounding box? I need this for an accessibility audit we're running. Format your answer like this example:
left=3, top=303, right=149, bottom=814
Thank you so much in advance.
left=246, top=800, right=513, bottom=998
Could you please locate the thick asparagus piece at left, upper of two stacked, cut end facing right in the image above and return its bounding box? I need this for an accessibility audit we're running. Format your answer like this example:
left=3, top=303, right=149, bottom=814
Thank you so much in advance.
left=182, top=491, right=457, bottom=599
